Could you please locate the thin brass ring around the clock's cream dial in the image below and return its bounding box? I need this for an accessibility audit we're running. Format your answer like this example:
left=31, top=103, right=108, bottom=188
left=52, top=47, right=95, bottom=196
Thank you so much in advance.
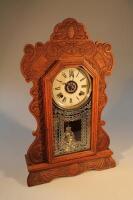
left=52, top=65, right=92, bottom=110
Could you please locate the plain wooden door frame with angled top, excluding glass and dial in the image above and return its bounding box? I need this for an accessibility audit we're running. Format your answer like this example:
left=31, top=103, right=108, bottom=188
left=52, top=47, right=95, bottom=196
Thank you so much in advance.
left=42, top=57, right=99, bottom=163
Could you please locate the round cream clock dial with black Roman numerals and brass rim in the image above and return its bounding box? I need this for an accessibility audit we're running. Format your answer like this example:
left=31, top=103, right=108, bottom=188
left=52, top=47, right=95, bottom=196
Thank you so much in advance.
left=52, top=67, right=91, bottom=109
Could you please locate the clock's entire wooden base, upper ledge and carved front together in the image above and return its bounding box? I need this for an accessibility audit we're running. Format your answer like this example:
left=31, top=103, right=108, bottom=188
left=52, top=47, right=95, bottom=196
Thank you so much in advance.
left=27, top=150, right=116, bottom=186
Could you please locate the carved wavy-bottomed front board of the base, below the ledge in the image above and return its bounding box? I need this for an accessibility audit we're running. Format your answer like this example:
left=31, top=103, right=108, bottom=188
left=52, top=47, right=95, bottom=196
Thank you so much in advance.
left=27, top=153, right=116, bottom=186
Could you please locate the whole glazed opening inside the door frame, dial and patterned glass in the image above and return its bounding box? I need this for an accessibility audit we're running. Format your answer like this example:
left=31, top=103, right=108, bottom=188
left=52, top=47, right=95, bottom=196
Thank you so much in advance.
left=52, top=65, right=92, bottom=156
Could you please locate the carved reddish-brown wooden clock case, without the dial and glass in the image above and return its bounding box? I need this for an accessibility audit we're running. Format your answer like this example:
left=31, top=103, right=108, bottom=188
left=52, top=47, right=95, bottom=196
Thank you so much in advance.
left=21, top=18, right=115, bottom=186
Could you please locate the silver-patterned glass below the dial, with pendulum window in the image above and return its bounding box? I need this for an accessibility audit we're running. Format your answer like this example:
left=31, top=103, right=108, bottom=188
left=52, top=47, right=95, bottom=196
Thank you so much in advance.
left=53, top=95, right=92, bottom=156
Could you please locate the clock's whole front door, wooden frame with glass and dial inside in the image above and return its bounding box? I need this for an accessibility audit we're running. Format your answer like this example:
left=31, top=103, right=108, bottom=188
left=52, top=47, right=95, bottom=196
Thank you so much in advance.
left=43, top=61, right=98, bottom=162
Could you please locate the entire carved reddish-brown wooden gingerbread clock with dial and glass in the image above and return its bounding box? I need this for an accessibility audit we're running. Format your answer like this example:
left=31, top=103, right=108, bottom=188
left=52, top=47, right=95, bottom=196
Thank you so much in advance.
left=21, top=18, right=115, bottom=186
